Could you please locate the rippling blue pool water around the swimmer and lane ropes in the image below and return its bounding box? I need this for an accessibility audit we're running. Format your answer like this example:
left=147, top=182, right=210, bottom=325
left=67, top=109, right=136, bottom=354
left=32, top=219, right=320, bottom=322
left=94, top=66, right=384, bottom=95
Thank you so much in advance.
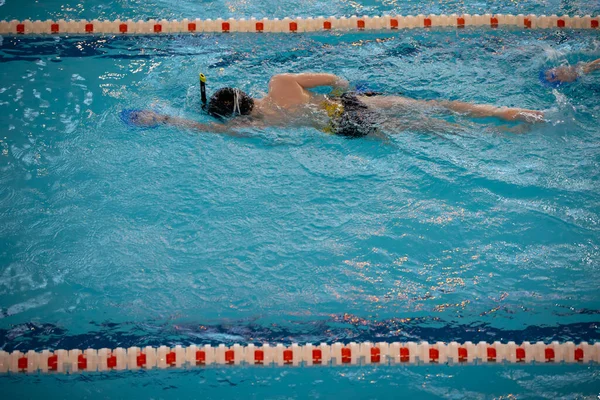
left=0, top=0, right=600, bottom=398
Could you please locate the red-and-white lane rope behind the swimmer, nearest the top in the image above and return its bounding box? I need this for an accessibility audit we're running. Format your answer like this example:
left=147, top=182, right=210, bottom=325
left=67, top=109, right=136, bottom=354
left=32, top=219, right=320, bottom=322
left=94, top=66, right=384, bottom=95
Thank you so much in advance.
left=0, top=14, right=600, bottom=35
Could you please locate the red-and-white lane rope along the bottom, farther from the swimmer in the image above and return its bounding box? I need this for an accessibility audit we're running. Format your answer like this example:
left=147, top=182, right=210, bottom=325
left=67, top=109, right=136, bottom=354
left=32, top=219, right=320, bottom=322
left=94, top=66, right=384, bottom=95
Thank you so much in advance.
left=0, top=342, right=600, bottom=373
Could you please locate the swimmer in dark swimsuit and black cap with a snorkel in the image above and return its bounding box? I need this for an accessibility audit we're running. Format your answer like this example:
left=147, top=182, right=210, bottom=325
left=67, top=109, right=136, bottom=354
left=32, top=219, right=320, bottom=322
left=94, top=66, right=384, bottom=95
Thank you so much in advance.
left=128, top=73, right=544, bottom=138
